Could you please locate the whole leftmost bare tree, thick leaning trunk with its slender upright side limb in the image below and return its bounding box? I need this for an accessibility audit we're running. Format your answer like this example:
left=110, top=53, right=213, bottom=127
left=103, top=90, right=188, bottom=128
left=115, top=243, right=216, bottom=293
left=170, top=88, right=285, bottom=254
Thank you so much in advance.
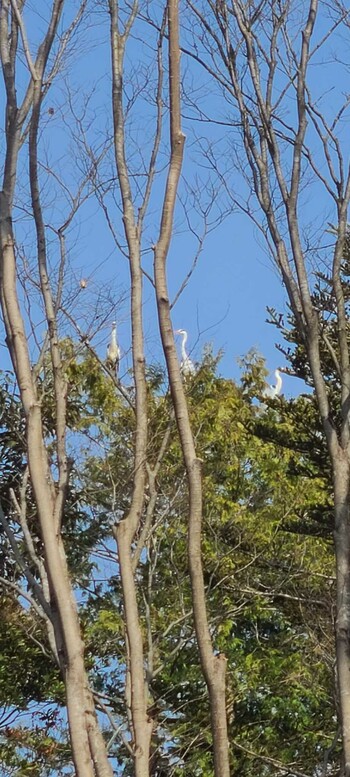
left=0, top=0, right=112, bottom=777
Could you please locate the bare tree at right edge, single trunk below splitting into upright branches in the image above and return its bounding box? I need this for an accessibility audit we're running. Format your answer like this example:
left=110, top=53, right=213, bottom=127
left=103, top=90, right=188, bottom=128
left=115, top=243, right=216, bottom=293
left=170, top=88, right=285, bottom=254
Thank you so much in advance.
left=189, top=0, right=350, bottom=777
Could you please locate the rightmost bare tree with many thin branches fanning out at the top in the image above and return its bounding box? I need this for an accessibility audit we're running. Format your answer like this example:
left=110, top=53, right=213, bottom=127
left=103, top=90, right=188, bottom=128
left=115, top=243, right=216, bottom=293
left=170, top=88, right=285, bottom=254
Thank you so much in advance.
left=185, top=0, right=350, bottom=777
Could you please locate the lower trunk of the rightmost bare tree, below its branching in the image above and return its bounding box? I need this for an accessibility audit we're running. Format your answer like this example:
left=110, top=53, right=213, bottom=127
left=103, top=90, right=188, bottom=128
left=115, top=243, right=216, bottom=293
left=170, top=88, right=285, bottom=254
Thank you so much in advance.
left=334, top=454, right=350, bottom=777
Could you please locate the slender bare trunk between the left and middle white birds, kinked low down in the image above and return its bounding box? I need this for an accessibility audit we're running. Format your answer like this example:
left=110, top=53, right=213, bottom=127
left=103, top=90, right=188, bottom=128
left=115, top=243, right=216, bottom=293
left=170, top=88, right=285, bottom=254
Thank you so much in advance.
left=109, top=0, right=153, bottom=777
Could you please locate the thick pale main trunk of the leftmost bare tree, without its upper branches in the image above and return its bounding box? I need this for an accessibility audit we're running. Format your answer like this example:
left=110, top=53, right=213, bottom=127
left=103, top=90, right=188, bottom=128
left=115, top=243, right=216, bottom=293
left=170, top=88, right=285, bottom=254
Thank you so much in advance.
left=0, top=193, right=112, bottom=777
